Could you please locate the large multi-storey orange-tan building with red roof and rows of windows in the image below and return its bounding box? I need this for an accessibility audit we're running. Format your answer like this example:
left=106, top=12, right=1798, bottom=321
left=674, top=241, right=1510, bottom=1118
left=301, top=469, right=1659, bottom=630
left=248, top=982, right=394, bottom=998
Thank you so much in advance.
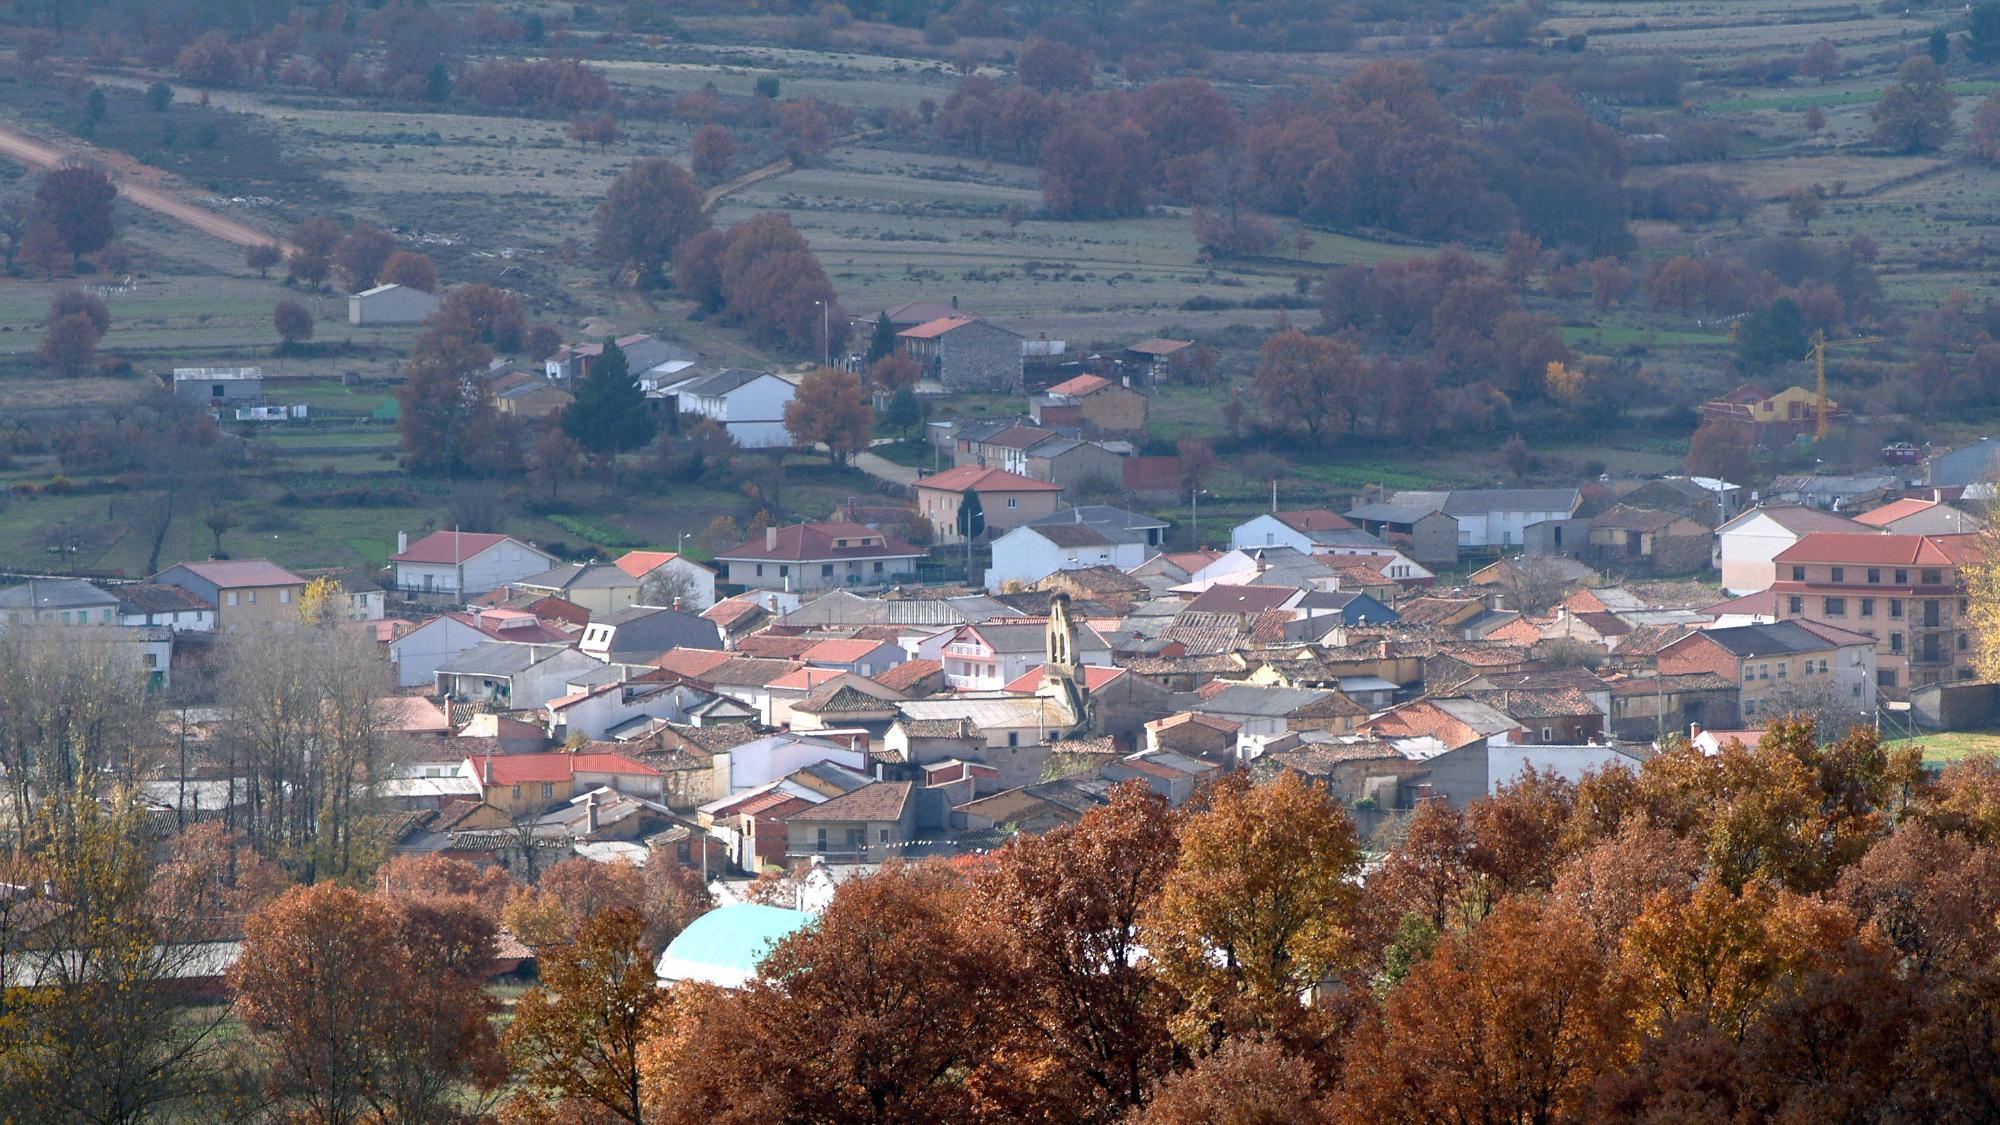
left=1770, top=532, right=1980, bottom=699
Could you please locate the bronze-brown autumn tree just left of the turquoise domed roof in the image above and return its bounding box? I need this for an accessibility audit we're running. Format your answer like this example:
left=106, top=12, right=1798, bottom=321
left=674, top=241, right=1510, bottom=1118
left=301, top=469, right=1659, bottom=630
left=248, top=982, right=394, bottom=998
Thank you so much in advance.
left=506, top=907, right=662, bottom=1125
